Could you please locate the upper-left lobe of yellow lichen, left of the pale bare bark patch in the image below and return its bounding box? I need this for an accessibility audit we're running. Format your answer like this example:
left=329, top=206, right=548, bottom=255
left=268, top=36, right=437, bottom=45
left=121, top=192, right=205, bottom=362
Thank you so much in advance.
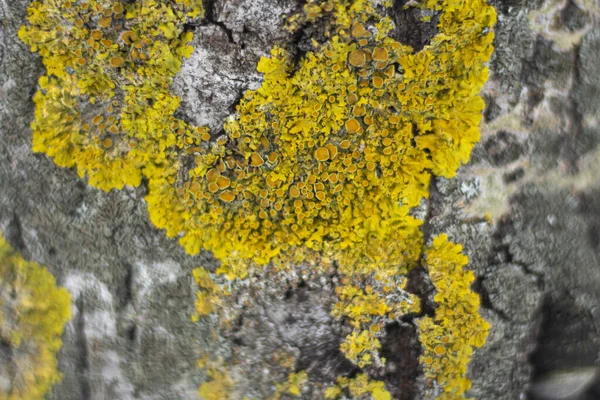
left=19, top=0, right=206, bottom=190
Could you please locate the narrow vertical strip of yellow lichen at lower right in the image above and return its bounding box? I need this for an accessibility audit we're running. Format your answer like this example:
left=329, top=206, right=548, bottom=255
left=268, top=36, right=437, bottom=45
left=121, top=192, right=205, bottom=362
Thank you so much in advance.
left=417, top=235, right=490, bottom=400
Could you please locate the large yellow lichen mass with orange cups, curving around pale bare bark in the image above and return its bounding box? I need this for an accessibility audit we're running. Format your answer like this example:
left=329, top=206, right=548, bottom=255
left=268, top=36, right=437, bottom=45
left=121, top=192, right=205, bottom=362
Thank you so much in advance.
left=20, top=0, right=496, bottom=396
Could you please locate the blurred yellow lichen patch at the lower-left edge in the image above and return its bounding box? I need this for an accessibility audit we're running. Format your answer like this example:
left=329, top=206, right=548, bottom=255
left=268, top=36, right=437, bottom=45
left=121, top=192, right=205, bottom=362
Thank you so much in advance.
left=0, top=236, right=71, bottom=400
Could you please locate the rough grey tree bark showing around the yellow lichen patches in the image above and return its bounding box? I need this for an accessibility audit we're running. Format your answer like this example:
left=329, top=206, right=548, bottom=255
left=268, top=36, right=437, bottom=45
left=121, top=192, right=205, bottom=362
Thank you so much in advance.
left=0, top=0, right=600, bottom=400
